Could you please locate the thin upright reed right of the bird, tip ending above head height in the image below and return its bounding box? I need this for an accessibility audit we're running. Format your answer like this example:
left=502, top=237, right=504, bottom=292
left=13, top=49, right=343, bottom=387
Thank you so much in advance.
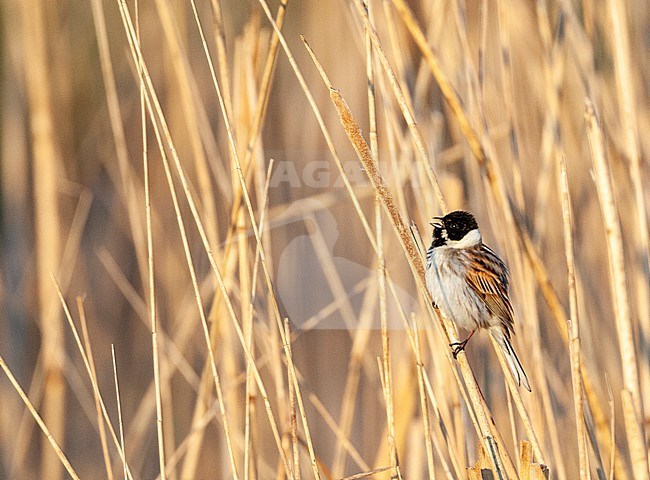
left=559, top=155, right=589, bottom=479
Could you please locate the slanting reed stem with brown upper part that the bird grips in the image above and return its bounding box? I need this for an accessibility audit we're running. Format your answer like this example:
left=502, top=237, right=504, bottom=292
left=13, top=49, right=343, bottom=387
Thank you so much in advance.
left=303, top=37, right=505, bottom=478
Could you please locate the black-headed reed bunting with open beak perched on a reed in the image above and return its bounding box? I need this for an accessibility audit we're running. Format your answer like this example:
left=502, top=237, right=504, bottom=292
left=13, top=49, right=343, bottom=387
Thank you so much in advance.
left=426, top=210, right=531, bottom=391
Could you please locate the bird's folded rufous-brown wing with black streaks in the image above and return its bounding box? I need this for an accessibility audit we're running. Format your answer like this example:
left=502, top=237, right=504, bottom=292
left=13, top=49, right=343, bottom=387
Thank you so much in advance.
left=465, top=247, right=514, bottom=338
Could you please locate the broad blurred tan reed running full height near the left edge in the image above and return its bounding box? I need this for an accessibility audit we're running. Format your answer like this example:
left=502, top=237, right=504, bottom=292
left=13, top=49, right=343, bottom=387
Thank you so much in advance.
left=21, top=0, right=66, bottom=480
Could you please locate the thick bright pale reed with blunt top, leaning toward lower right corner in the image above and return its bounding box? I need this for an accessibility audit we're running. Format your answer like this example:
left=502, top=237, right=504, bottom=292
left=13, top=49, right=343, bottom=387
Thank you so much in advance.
left=585, top=99, right=648, bottom=480
